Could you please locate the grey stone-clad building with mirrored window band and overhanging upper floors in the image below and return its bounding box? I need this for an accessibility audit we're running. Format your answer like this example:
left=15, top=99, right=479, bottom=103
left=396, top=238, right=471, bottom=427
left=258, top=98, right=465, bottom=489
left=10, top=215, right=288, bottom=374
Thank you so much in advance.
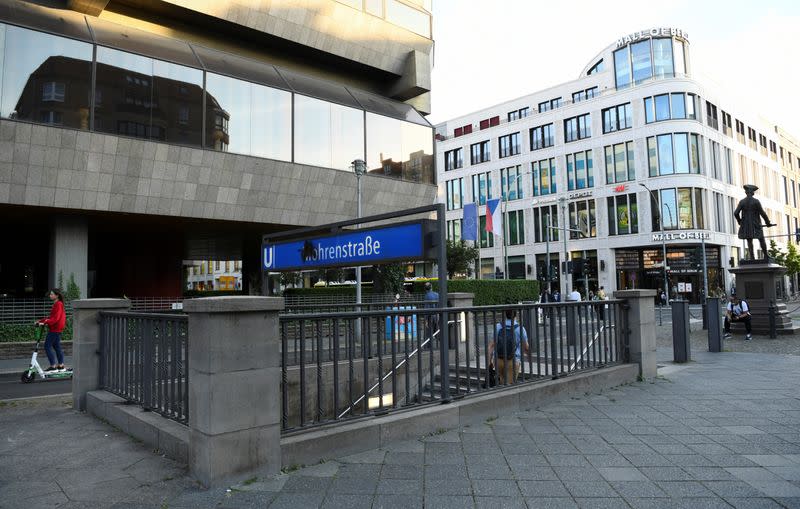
left=0, top=0, right=436, bottom=297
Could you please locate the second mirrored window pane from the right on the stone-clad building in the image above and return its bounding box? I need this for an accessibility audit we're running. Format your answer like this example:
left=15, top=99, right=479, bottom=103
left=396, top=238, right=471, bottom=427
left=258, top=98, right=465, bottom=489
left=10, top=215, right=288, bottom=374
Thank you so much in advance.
left=294, top=94, right=362, bottom=169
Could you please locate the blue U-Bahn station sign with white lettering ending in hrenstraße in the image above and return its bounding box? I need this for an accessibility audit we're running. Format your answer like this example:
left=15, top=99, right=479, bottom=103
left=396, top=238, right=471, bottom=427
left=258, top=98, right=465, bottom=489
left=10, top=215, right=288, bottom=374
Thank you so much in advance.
left=261, top=220, right=430, bottom=272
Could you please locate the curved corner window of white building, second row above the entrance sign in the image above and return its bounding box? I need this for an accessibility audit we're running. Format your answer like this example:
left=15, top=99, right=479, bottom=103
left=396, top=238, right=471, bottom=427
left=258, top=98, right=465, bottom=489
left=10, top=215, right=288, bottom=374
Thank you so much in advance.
left=647, top=133, right=700, bottom=177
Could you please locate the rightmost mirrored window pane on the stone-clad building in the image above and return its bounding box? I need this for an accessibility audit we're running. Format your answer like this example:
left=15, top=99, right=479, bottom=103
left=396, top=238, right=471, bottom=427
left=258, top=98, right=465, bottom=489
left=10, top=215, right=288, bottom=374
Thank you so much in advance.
left=366, top=112, right=434, bottom=184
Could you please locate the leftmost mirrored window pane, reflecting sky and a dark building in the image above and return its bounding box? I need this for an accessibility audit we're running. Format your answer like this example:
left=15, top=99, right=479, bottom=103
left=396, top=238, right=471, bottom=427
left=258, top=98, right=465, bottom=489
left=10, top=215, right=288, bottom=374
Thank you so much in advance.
left=0, top=25, right=92, bottom=129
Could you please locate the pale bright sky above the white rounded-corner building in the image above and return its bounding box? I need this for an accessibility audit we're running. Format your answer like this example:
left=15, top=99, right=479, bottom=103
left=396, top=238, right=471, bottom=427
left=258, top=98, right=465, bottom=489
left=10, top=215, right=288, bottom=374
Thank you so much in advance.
left=428, top=0, right=800, bottom=139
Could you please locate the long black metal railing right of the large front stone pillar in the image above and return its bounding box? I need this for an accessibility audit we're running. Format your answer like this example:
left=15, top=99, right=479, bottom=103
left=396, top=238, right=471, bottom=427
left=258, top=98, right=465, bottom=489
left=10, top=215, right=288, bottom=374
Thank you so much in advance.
left=280, top=300, right=628, bottom=432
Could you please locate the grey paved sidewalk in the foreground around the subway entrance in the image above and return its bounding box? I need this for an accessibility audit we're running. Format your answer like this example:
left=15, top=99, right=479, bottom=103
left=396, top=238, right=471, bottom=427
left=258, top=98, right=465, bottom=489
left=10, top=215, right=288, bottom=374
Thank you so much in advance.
left=0, top=342, right=800, bottom=509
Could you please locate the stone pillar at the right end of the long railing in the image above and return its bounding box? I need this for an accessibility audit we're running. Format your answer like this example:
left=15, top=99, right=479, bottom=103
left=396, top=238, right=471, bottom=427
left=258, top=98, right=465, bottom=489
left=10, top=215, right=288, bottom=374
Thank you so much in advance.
left=614, top=290, right=658, bottom=380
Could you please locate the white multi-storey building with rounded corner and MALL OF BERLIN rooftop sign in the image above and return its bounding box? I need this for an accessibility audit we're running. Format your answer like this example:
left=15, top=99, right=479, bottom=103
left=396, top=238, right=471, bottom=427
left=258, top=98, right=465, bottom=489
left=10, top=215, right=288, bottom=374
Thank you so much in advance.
left=436, top=27, right=800, bottom=302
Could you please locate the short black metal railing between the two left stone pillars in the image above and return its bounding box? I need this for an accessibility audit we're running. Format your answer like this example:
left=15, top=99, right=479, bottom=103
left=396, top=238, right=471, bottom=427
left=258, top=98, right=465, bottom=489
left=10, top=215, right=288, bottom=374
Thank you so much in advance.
left=100, top=311, right=189, bottom=424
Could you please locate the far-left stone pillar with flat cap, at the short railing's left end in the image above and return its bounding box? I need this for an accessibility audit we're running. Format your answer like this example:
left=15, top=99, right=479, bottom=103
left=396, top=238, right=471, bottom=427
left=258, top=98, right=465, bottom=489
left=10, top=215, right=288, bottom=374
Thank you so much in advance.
left=72, top=299, right=131, bottom=411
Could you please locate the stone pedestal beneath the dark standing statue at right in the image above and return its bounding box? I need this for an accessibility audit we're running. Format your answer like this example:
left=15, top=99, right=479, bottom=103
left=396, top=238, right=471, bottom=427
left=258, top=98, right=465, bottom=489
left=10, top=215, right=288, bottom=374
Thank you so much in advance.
left=730, top=260, right=800, bottom=335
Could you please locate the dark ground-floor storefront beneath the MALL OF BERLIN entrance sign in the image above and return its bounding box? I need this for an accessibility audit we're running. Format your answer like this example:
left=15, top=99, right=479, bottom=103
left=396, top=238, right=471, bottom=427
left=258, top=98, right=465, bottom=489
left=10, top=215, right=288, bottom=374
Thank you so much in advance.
left=615, top=244, right=725, bottom=304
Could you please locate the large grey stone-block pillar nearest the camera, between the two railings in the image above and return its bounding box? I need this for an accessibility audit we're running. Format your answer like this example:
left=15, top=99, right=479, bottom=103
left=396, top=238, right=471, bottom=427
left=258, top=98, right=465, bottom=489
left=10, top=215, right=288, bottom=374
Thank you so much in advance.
left=183, top=296, right=284, bottom=486
